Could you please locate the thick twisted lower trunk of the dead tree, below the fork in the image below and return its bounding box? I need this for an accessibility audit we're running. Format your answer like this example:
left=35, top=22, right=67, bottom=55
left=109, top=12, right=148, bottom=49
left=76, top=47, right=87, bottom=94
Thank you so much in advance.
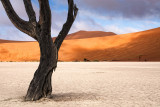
left=25, top=35, right=57, bottom=101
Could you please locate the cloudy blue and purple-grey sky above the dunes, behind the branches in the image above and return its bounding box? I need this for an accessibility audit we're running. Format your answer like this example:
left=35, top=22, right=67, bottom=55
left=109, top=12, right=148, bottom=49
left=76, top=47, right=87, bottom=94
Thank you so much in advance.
left=0, top=0, right=160, bottom=41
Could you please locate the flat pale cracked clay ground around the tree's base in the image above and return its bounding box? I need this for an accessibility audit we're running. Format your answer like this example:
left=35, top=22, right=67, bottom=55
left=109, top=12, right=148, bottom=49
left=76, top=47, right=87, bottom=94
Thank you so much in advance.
left=0, top=62, right=160, bottom=107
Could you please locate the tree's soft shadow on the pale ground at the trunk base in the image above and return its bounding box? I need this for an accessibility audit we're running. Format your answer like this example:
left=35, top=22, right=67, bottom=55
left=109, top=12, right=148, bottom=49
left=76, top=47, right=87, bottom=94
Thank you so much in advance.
left=0, top=93, right=99, bottom=103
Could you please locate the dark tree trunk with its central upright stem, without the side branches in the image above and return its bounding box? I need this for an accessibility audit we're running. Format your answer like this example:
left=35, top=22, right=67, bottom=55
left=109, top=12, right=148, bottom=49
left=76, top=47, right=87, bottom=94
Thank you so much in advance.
left=24, top=0, right=57, bottom=101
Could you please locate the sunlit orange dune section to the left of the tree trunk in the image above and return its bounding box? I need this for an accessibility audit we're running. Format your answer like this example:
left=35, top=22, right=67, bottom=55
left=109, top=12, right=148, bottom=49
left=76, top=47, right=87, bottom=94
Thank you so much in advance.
left=0, top=42, right=40, bottom=61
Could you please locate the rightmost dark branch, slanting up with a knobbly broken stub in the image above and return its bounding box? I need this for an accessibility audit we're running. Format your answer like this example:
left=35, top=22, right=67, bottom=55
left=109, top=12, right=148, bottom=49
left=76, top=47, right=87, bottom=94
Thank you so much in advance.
left=54, top=0, right=78, bottom=51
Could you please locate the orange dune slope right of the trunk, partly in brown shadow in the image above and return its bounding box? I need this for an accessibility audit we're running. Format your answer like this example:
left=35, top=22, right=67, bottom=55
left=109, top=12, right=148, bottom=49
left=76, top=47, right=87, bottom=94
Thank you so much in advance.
left=59, top=28, right=160, bottom=61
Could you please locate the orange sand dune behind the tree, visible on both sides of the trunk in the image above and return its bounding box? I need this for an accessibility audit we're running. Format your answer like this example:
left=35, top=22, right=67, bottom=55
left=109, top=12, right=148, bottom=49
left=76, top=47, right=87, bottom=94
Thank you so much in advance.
left=0, top=28, right=160, bottom=61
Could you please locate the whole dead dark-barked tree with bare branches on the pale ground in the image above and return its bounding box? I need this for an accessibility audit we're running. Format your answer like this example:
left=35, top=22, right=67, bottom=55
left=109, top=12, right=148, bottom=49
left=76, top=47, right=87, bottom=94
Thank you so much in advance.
left=1, top=0, right=78, bottom=101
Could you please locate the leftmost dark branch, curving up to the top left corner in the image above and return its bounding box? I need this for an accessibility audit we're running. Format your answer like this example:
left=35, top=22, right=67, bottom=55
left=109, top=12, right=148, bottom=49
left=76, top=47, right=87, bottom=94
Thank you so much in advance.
left=1, top=0, right=36, bottom=39
